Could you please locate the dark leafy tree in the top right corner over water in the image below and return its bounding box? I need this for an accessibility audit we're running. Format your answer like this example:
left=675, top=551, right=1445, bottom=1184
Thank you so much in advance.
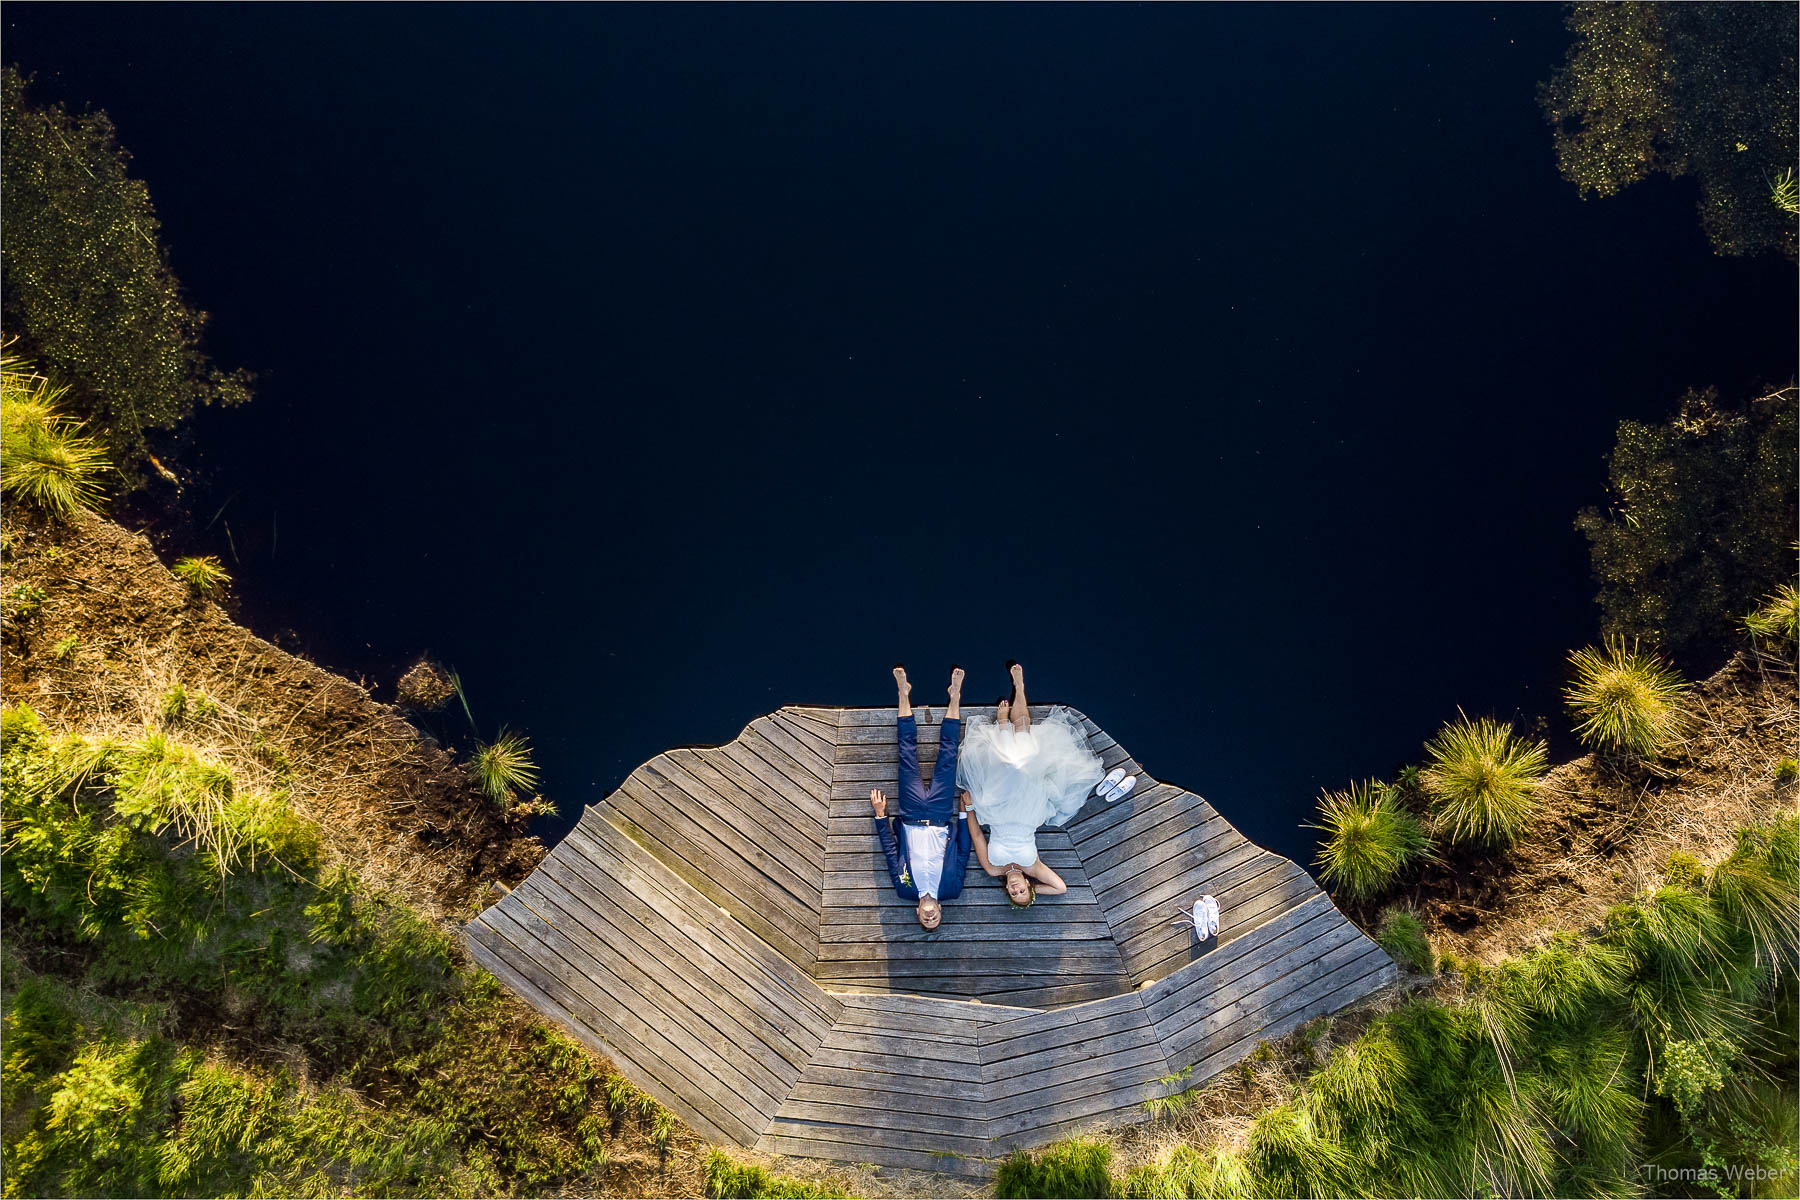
left=1539, top=2, right=1800, bottom=259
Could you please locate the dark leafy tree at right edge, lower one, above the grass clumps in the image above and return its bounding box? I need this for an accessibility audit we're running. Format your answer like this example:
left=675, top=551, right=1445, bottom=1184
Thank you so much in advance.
left=1575, top=387, right=1800, bottom=655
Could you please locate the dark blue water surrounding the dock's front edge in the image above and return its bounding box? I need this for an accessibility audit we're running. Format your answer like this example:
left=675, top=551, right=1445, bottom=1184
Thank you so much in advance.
left=5, top=4, right=1796, bottom=874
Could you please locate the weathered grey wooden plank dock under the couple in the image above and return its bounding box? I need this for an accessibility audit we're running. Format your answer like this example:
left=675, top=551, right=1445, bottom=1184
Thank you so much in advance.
left=464, top=705, right=1399, bottom=1177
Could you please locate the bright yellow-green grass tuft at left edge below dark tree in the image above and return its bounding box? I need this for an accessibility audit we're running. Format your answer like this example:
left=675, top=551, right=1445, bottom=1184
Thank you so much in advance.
left=0, top=358, right=112, bottom=520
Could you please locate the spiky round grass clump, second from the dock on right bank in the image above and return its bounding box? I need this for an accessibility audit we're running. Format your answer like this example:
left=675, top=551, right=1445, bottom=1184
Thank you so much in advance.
left=1418, top=718, right=1548, bottom=846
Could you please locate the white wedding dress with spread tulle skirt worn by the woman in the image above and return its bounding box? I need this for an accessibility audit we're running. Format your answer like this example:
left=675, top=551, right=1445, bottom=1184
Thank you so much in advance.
left=956, top=709, right=1105, bottom=867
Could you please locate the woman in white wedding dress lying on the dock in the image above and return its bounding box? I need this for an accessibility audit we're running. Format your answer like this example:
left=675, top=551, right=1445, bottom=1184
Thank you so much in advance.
left=956, top=662, right=1136, bottom=909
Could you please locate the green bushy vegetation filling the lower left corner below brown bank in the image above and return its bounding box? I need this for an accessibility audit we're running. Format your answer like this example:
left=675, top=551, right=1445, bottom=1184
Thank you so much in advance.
left=0, top=705, right=648, bottom=1195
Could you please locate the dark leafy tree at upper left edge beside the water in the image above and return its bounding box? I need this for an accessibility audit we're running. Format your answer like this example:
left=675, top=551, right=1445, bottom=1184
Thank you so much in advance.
left=0, top=67, right=250, bottom=477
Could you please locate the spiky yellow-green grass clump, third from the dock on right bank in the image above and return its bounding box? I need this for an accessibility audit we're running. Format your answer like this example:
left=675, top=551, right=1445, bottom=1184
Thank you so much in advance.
left=1564, top=640, right=1692, bottom=757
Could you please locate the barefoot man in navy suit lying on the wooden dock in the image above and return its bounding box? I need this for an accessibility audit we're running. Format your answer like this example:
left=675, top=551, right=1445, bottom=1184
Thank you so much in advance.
left=869, top=666, right=970, bottom=930
